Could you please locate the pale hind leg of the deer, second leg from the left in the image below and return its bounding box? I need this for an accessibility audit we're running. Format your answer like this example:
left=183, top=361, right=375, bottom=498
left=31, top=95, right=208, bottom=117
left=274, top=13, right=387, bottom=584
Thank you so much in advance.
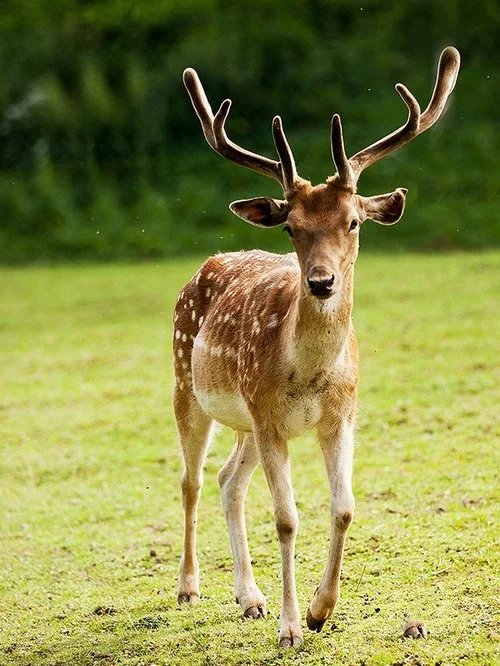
left=219, top=432, right=266, bottom=619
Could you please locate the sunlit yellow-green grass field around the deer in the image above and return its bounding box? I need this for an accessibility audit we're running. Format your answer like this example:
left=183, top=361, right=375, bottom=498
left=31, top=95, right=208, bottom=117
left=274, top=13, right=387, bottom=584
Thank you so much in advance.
left=0, top=253, right=500, bottom=666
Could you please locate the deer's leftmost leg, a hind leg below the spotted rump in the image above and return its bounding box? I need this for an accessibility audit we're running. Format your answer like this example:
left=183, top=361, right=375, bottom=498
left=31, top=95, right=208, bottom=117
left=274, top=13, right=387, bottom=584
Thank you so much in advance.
left=174, top=388, right=212, bottom=604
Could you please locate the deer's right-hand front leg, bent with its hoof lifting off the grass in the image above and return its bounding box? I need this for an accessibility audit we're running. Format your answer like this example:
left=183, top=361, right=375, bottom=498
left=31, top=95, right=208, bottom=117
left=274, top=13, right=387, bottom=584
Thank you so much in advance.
left=307, top=419, right=354, bottom=632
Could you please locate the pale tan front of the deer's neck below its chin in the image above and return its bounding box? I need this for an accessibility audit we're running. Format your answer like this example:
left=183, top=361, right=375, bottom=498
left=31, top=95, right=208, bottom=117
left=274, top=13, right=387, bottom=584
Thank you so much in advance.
left=292, top=269, right=354, bottom=379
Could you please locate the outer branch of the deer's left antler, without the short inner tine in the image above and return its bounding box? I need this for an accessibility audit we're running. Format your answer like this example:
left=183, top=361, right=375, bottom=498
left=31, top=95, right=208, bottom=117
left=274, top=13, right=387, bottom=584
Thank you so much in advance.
left=183, top=68, right=286, bottom=190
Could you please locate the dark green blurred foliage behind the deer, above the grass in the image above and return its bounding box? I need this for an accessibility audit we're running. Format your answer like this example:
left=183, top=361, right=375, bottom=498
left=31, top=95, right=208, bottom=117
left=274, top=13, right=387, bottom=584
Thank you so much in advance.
left=0, top=0, right=500, bottom=263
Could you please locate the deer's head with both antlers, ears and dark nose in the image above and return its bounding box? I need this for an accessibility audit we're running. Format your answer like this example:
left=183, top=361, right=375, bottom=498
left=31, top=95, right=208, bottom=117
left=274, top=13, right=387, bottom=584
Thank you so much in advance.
left=184, top=47, right=460, bottom=299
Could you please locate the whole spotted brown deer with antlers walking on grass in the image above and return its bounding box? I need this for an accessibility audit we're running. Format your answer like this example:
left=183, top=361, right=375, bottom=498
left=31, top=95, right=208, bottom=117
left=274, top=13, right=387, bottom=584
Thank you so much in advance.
left=173, top=46, right=460, bottom=648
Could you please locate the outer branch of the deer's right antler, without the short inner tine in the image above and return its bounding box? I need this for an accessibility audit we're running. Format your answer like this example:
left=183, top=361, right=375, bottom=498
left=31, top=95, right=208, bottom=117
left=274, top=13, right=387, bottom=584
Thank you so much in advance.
left=349, top=46, right=460, bottom=181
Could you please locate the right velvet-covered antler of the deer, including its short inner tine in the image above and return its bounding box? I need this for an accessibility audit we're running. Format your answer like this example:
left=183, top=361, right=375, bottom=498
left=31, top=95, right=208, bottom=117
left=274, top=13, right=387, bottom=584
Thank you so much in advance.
left=332, top=46, right=460, bottom=187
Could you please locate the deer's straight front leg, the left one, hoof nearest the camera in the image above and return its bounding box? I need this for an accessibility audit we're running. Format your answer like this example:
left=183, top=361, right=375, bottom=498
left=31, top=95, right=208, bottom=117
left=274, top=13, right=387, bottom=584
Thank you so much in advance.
left=256, top=434, right=302, bottom=648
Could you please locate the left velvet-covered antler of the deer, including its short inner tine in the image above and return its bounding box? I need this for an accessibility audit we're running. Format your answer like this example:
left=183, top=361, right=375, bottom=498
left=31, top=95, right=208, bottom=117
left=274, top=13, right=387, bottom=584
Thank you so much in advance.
left=183, top=68, right=297, bottom=194
